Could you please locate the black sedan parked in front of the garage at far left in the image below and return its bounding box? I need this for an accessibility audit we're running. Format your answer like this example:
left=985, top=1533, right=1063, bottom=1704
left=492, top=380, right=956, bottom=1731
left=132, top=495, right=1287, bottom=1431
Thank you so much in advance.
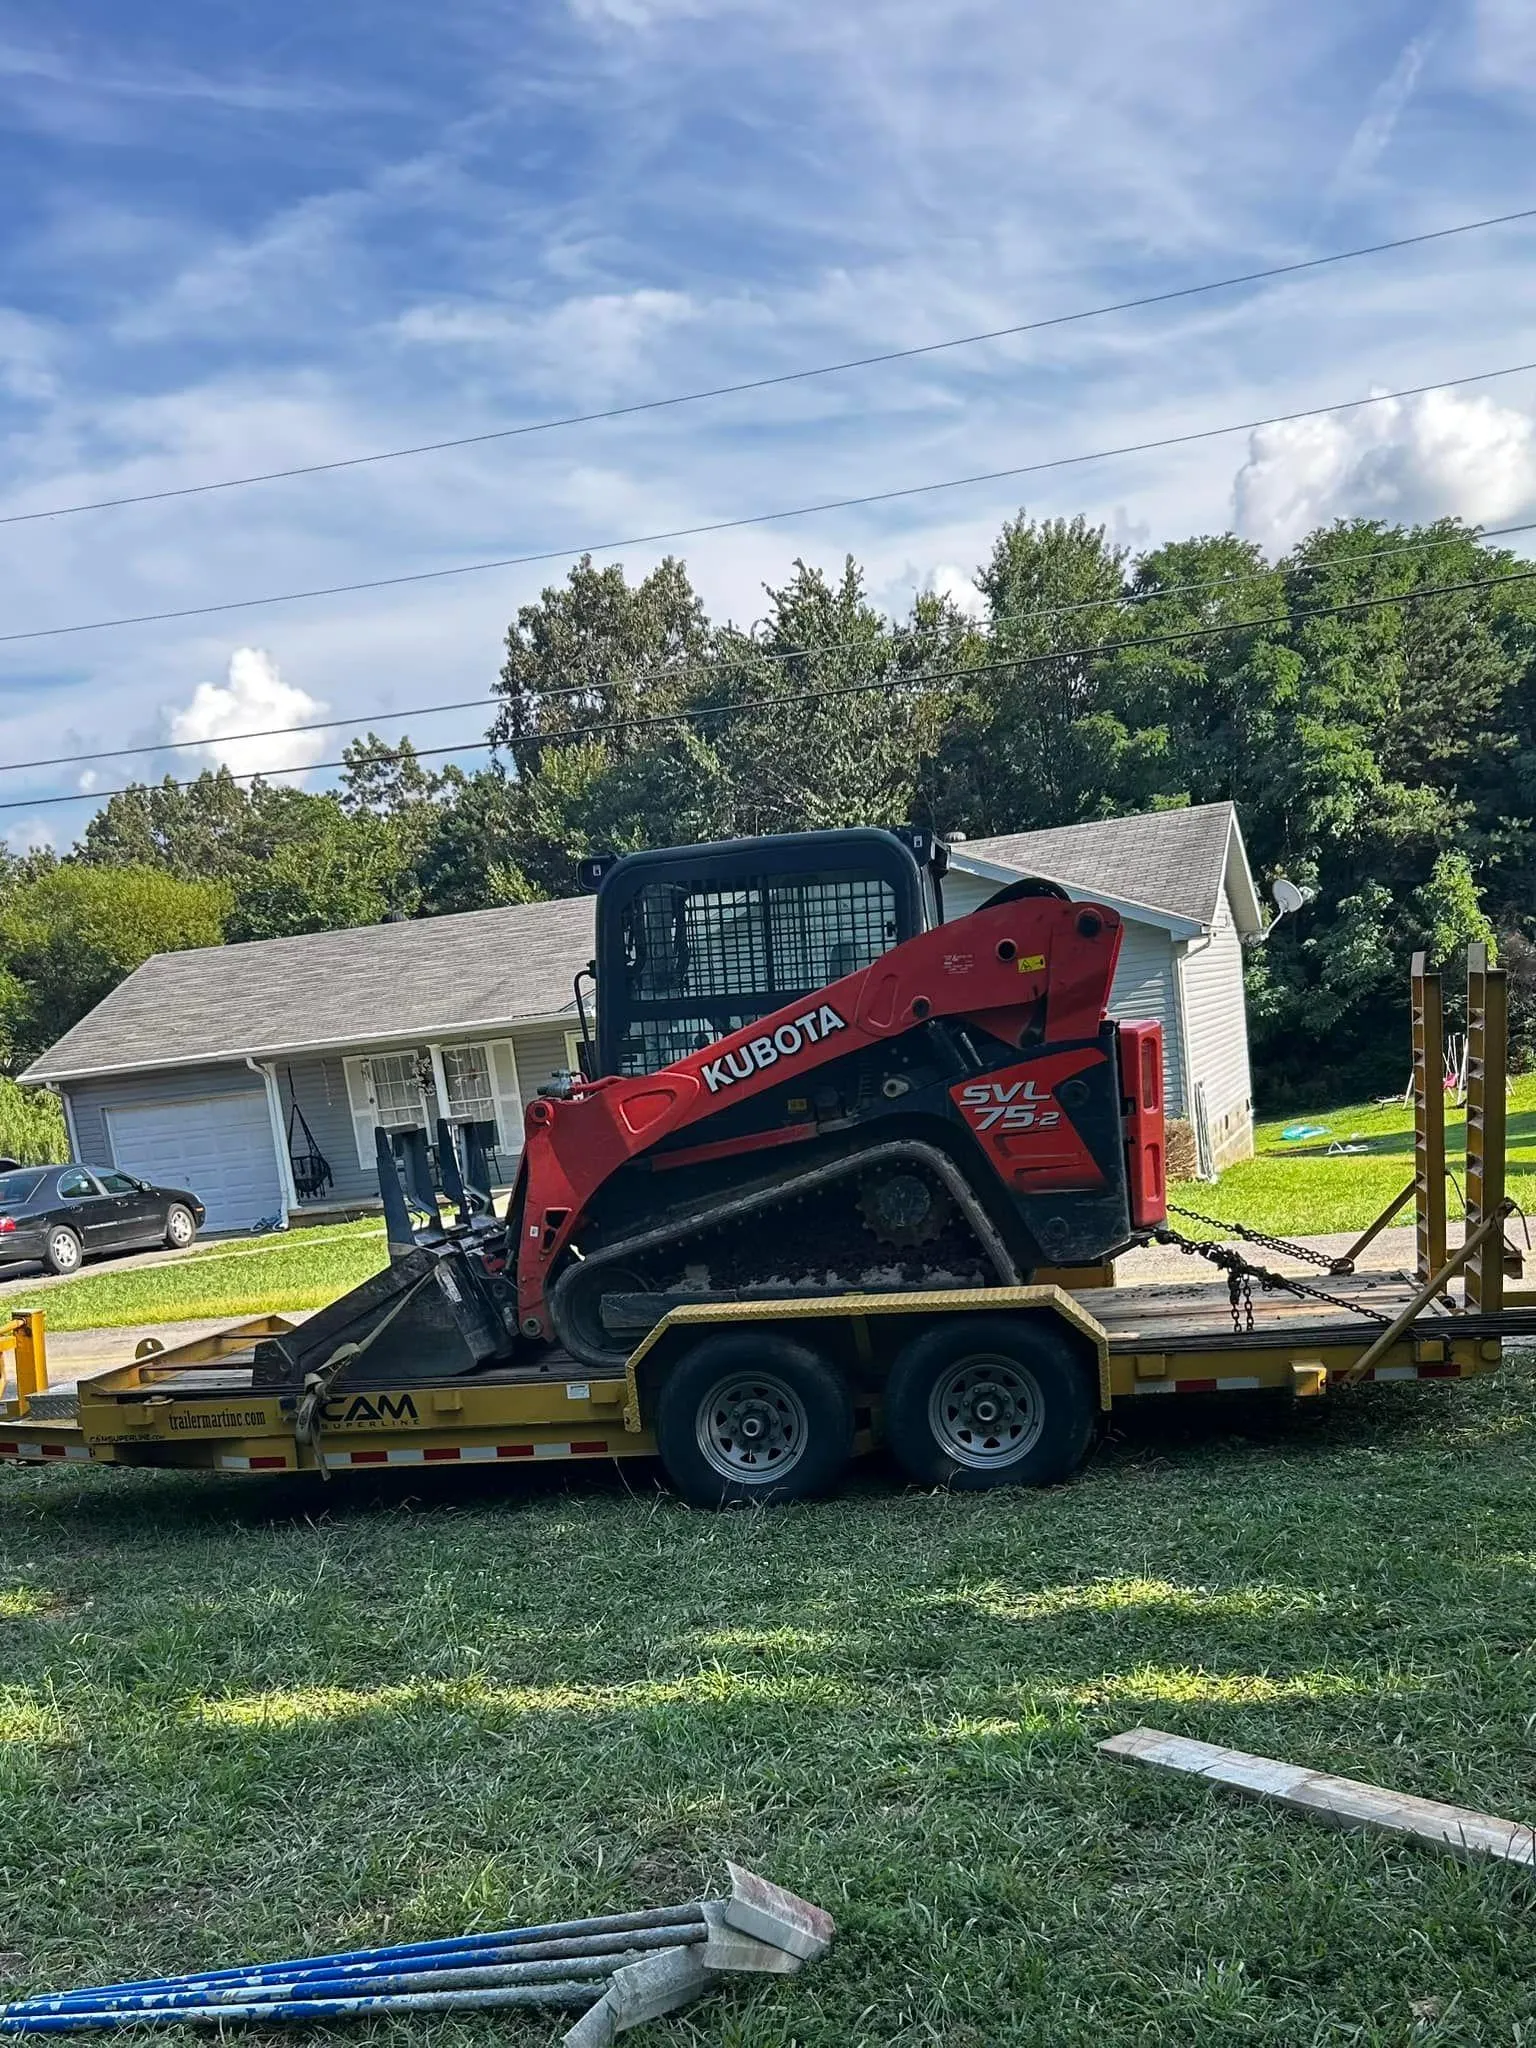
left=0, top=1165, right=205, bottom=1274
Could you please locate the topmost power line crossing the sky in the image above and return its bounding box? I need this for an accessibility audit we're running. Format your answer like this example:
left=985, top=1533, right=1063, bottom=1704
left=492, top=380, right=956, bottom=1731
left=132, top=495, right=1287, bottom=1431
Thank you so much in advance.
left=0, top=207, right=1536, bottom=526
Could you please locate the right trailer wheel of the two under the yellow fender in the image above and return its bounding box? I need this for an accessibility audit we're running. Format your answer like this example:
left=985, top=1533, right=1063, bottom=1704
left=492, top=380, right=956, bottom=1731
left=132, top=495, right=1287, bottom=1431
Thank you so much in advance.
left=885, top=1315, right=1098, bottom=1493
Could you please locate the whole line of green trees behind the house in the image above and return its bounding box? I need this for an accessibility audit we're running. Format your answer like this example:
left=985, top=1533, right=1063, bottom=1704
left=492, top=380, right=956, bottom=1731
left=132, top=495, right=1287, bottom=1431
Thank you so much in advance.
left=0, top=514, right=1536, bottom=1100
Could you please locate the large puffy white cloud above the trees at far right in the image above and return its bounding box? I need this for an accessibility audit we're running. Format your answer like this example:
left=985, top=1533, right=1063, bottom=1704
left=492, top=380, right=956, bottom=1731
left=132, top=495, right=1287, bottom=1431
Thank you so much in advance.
left=1233, top=391, right=1536, bottom=547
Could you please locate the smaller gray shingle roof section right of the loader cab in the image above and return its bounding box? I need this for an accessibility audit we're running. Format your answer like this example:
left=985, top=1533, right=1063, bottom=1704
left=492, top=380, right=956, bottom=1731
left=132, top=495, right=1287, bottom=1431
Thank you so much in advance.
left=954, top=803, right=1235, bottom=924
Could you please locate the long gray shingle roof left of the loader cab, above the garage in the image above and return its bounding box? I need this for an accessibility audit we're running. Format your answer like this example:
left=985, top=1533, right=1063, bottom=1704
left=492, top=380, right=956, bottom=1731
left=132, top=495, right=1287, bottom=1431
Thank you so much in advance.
left=23, top=897, right=592, bottom=1081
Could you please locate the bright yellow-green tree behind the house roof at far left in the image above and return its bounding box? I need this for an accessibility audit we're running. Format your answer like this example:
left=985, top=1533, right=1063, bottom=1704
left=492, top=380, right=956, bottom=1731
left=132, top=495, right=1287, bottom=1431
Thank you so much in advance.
left=0, top=862, right=229, bottom=1073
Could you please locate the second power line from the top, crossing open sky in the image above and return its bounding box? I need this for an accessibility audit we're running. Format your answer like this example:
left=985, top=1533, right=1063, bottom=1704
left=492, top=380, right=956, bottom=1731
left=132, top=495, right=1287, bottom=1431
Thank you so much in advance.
left=0, top=362, right=1536, bottom=645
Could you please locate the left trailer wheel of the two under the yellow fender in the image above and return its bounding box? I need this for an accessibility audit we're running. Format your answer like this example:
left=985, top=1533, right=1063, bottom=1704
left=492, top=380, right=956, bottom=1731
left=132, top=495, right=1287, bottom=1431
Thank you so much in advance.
left=655, top=1331, right=854, bottom=1507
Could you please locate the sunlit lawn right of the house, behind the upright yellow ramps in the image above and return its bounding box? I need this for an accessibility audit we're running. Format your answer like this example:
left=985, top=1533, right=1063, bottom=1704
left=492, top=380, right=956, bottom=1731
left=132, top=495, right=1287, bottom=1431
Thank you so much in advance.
left=1169, top=1075, right=1536, bottom=1241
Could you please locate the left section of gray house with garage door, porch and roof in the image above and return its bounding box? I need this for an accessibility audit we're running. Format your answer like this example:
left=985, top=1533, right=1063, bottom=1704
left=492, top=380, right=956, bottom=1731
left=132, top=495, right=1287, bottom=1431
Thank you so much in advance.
left=20, top=897, right=592, bottom=1231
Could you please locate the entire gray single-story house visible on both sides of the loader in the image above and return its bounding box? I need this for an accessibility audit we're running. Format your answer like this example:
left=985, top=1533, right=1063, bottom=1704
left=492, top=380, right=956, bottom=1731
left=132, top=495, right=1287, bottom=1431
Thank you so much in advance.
left=20, top=803, right=1262, bottom=1231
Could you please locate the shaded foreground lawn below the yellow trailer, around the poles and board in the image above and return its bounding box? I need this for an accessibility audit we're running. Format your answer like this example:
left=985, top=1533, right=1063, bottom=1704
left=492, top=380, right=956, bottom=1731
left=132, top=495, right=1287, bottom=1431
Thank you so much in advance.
left=0, top=1366, right=1536, bottom=2048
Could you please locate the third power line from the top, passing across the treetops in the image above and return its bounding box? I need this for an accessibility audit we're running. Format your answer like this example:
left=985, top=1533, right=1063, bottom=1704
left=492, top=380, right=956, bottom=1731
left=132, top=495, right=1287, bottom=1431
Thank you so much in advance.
left=12, top=520, right=1536, bottom=782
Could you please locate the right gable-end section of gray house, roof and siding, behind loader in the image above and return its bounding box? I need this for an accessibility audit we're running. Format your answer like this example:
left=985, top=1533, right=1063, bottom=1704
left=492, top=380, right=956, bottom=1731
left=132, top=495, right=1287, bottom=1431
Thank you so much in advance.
left=944, top=803, right=1264, bottom=1169
